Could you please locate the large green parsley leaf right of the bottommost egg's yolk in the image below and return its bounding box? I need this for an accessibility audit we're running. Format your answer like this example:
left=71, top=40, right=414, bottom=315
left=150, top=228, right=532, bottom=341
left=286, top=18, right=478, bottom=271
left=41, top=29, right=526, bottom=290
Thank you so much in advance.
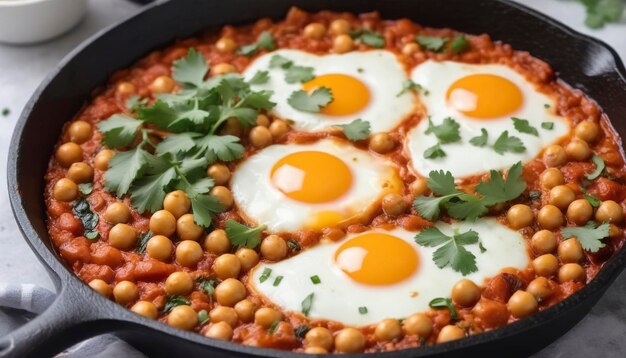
left=415, top=227, right=478, bottom=276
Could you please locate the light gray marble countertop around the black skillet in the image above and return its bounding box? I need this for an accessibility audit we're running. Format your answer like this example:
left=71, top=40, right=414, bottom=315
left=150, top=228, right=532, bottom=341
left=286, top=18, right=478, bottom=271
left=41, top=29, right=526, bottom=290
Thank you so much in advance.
left=0, top=0, right=626, bottom=357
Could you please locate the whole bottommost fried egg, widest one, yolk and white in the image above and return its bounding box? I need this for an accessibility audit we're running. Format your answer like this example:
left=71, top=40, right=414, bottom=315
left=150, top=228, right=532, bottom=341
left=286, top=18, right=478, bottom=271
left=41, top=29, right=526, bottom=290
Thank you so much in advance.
left=248, top=218, right=529, bottom=326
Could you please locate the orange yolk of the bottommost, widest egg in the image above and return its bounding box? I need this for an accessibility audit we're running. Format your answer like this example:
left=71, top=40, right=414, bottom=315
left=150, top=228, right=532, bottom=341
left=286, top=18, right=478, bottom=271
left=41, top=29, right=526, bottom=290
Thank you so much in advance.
left=335, top=233, right=418, bottom=286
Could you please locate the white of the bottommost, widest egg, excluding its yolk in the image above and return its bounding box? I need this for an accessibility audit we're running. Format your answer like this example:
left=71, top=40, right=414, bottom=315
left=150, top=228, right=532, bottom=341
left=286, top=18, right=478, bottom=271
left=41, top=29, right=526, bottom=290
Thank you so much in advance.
left=248, top=218, right=529, bottom=326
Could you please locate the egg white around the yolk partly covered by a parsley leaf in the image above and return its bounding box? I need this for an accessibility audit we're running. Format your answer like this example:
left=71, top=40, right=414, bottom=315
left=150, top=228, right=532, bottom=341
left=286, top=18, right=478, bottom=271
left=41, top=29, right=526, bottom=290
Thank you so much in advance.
left=244, top=50, right=415, bottom=132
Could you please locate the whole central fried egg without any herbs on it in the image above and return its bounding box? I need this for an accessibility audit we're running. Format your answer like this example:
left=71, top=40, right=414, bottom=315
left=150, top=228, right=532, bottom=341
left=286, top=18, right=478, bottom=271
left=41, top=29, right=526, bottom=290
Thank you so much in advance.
left=231, top=139, right=403, bottom=232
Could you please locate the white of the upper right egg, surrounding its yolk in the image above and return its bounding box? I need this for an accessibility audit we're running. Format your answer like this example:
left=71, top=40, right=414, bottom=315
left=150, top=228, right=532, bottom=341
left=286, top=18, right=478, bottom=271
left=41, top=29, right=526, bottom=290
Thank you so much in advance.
left=406, top=60, right=570, bottom=177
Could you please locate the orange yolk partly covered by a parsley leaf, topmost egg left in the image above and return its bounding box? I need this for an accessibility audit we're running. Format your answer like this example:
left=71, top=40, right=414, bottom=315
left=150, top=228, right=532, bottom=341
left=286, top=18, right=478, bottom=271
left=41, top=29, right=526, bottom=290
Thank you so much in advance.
left=302, top=73, right=370, bottom=116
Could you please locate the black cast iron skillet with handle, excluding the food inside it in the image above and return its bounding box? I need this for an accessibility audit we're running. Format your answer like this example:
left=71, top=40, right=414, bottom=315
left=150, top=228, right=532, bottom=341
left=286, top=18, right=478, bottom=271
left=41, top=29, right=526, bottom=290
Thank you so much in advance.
left=0, top=0, right=626, bottom=357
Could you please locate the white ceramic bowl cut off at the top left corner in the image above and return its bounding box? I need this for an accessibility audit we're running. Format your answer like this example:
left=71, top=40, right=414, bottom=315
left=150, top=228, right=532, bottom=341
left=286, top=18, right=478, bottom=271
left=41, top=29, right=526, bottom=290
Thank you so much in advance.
left=0, top=0, right=87, bottom=44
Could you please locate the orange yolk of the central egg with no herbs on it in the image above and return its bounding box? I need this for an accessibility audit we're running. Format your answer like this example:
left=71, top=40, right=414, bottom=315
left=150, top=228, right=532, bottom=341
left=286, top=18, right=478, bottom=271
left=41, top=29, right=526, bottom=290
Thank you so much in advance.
left=270, top=151, right=352, bottom=204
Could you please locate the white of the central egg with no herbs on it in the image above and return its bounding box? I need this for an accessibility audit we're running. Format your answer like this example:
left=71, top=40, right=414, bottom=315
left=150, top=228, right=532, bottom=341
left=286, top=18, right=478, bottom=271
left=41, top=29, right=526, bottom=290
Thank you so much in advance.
left=231, top=139, right=401, bottom=232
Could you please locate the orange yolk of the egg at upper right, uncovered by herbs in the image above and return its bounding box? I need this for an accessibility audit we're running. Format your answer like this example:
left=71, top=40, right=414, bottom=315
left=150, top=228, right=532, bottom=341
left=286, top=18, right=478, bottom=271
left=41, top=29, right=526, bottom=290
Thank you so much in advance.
left=446, top=73, right=524, bottom=119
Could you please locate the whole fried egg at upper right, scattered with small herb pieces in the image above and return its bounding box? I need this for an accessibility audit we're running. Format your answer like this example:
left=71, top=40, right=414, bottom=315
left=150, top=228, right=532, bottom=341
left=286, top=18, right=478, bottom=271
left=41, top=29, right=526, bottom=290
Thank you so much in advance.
left=406, top=61, right=570, bottom=177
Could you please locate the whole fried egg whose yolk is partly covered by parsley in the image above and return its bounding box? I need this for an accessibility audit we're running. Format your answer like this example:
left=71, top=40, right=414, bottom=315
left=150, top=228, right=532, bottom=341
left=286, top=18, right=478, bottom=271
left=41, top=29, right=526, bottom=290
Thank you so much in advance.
left=244, top=50, right=415, bottom=132
